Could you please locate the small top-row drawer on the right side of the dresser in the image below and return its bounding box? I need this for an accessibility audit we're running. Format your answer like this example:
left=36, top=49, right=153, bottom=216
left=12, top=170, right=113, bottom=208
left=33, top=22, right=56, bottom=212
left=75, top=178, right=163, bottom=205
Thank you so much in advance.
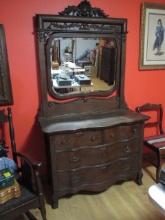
left=103, top=125, right=139, bottom=143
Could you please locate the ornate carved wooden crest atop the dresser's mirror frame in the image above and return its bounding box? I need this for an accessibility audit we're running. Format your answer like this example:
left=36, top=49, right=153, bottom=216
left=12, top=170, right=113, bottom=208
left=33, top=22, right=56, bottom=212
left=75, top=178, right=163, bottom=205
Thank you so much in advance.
left=59, top=0, right=108, bottom=18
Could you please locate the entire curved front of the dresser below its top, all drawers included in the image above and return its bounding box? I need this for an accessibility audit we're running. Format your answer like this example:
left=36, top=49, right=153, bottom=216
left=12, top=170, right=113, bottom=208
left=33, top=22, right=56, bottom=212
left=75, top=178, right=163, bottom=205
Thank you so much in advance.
left=46, top=123, right=143, bottom=206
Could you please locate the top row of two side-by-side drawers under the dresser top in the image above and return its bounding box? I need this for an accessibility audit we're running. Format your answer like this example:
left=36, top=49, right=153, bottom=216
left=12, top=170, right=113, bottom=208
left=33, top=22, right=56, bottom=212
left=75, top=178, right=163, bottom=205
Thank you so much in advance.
left=55, top=126, right=139, bottom=150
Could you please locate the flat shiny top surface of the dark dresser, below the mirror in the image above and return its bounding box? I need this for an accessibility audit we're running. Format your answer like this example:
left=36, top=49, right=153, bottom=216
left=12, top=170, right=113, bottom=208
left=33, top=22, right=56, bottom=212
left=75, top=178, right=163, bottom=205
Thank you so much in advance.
left=39, top=110, right=147, bottom=134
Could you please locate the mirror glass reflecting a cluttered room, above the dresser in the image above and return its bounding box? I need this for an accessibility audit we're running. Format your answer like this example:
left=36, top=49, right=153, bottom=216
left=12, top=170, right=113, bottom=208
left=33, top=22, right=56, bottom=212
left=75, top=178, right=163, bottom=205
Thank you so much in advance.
left=50, top=37, right=117, bottom=94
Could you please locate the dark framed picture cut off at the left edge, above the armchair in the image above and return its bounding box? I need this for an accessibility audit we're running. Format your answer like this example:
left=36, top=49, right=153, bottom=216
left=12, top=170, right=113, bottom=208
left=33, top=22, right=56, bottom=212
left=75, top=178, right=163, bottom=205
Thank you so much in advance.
left=0, top=24, right=13, bottom=106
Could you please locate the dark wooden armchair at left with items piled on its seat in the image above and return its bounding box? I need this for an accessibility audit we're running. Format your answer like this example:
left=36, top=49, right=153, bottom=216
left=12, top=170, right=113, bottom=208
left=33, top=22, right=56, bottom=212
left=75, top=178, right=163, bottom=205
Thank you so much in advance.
left=0, top=107, right=46, bottom=220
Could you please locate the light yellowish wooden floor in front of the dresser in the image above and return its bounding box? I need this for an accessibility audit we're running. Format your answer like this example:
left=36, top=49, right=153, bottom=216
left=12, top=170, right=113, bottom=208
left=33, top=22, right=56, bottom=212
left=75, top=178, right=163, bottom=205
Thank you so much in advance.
left=30, top=167, right=165, bottom=220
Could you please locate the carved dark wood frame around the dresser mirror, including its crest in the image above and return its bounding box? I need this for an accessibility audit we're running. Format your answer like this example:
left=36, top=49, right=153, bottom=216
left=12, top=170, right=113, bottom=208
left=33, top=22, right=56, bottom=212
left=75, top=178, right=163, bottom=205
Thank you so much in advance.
left=35, top=0, right=127, bottom=112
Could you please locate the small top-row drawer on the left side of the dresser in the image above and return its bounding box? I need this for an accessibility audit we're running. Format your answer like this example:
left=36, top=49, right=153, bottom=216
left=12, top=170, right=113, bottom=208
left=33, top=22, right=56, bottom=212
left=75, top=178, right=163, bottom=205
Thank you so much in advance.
left=54, top=131, right=102, bottom=149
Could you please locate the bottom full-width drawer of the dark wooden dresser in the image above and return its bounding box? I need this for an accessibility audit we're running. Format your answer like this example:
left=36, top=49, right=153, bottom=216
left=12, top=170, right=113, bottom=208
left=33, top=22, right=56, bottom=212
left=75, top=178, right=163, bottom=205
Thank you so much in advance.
left=57, top=156, right=138, bottom=190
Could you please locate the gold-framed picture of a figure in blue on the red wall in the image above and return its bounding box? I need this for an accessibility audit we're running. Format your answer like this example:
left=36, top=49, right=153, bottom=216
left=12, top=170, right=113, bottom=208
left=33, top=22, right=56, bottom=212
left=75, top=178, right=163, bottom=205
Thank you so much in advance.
left=139, top=2, right=165, bottom=70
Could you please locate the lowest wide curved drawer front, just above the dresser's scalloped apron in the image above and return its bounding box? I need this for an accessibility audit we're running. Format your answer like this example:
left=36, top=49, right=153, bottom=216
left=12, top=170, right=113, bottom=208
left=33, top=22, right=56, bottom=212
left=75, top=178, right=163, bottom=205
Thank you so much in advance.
left=57, top=155, right=138, bottom=195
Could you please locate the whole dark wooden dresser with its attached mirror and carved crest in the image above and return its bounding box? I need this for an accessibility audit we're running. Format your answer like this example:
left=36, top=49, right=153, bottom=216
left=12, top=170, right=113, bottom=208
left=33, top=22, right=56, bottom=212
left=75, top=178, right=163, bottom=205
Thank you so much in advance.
left=36, top=0, right=146, bottom=208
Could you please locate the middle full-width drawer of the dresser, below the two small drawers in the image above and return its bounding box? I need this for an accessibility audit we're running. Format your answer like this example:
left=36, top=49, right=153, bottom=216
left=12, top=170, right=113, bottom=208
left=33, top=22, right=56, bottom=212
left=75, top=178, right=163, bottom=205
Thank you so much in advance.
left=56, top=139, right=139, bottom=170
